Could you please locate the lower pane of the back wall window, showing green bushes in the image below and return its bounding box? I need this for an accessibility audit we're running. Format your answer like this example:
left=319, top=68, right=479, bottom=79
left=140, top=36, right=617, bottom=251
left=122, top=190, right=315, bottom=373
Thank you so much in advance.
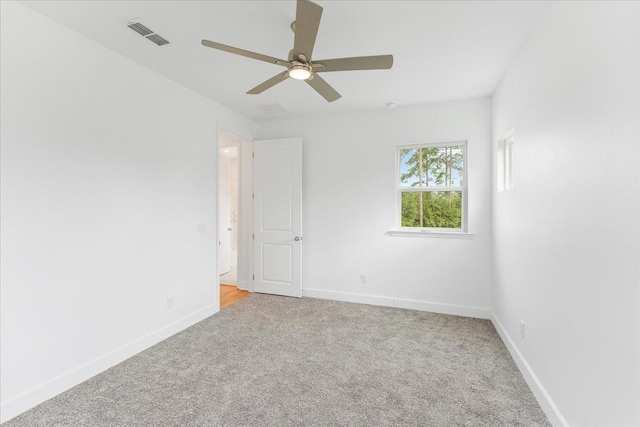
left=401, top=191, right=462, bottom=228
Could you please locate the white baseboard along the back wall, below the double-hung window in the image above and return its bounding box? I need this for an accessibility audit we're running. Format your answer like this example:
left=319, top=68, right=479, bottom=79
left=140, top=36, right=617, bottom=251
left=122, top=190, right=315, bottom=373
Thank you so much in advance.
left=302, top=288, right=491, bottom=319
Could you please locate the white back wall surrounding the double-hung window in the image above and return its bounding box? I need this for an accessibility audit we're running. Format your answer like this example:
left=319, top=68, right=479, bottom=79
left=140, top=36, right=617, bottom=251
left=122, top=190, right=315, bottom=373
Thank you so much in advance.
left=259, top=98, right=491, bottom=317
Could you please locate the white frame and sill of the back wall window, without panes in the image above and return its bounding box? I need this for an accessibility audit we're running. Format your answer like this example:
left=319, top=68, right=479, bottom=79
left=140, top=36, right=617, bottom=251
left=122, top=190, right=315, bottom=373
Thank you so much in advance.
left=390, top=141, right=469, bottom=235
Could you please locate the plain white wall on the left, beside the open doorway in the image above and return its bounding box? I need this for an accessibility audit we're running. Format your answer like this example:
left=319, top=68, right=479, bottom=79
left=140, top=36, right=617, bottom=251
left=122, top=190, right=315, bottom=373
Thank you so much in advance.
left=0, top=1, right=255, bottom=420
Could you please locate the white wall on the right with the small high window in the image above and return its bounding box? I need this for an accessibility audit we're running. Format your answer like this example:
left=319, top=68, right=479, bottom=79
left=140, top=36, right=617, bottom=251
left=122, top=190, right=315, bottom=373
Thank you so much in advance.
left=493, top=2, right=640, bottom=426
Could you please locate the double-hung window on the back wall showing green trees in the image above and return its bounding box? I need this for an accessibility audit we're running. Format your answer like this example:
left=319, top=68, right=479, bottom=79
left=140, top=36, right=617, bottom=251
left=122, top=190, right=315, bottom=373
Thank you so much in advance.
left=396, top=141, right=467, bottom=231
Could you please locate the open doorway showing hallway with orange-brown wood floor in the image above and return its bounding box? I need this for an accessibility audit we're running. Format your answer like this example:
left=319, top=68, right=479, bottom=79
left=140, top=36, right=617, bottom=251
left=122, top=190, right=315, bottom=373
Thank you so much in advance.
left=218, top=132, right=248, bottom=309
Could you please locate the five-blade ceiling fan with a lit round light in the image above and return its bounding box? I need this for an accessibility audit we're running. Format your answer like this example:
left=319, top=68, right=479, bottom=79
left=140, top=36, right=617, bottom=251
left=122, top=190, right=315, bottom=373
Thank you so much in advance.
left=202, top=0, right=393, bottom=102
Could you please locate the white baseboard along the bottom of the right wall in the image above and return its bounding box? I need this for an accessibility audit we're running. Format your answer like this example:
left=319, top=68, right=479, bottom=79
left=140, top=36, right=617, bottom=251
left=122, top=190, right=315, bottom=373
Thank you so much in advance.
left=491, top=312, right=569, bottom=427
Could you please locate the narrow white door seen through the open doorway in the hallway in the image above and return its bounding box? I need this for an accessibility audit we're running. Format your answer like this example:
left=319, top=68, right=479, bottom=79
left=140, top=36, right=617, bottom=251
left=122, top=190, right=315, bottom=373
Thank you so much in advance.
left=218, top=150, right=231, bottom=274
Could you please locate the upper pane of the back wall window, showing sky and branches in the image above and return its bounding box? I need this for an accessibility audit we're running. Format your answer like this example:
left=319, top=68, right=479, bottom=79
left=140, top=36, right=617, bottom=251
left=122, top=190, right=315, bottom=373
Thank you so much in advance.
left=400, top=145, right=464, bottom=187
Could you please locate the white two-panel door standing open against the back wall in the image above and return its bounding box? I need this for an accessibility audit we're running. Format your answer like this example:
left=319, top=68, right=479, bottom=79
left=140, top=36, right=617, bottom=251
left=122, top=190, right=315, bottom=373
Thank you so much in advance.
left=253, top=138, right=302, bottom=297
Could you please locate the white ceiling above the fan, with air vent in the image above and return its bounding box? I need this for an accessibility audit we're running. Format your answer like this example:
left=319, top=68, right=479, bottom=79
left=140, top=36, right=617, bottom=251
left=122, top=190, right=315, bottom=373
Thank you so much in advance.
left=21, top=0, right=546, bottom=121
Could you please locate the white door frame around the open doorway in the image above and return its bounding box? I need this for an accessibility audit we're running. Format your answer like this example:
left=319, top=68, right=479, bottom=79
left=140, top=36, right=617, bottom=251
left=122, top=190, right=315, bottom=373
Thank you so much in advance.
left=215, top=124, right=253, bottom=309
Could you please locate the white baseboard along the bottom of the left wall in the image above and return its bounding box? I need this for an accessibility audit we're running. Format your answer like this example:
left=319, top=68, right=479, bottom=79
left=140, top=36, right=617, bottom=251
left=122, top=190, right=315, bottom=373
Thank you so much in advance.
left=0, top=304, right=218, bottom=423
